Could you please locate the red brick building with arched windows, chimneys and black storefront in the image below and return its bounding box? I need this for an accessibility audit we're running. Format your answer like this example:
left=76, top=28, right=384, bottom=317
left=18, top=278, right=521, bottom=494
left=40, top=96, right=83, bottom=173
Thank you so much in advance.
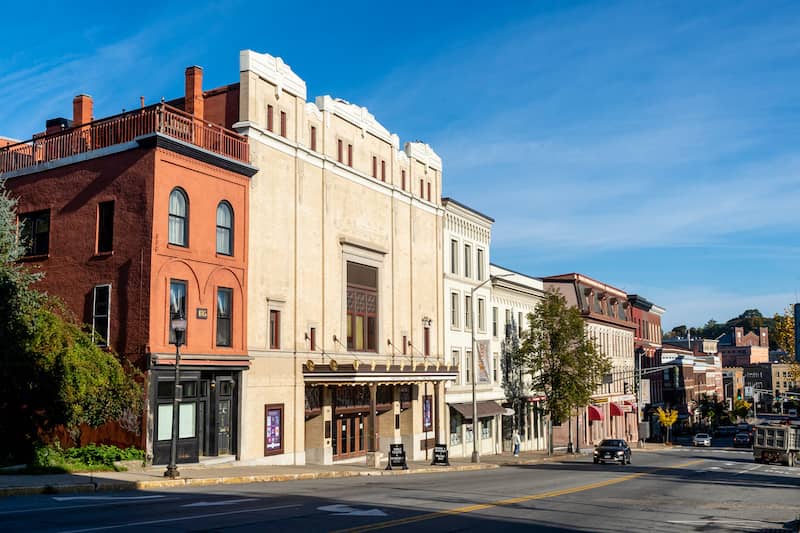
left=0, top=67, right=255, bottom=463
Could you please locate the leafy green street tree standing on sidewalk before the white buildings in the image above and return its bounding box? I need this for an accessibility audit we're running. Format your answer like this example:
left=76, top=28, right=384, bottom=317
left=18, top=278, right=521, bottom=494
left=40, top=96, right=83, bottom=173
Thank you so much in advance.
left=520, top=290, right=611, bottom=452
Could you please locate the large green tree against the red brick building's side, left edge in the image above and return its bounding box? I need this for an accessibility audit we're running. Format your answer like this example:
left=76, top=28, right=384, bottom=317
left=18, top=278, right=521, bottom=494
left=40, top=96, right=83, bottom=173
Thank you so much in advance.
left=0, top=186, right=141, bottom=461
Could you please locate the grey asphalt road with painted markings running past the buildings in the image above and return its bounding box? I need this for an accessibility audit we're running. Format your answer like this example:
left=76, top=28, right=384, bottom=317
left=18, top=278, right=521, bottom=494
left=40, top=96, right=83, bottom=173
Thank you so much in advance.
left=0, top=447, right=800, bottom=532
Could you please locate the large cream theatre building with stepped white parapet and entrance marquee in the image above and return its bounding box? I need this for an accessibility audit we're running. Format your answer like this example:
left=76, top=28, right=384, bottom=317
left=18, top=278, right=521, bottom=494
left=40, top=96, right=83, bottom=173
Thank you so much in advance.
left=234, top=50, right=458, bottom=464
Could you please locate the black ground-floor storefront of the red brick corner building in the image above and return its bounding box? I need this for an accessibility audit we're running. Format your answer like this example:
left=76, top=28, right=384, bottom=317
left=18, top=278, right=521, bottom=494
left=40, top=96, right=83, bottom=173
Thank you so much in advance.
left=149, top=364, right=241, bottom=465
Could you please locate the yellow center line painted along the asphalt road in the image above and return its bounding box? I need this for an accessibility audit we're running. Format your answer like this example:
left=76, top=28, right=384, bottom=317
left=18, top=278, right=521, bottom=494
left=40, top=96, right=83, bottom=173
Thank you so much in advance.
left=333, top=459, right=705, bottom=533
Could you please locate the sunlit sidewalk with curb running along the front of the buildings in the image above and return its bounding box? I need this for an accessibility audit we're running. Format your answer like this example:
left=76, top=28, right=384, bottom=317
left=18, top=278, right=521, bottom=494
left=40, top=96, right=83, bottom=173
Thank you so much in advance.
left=0, top=444, right=676, bottom=496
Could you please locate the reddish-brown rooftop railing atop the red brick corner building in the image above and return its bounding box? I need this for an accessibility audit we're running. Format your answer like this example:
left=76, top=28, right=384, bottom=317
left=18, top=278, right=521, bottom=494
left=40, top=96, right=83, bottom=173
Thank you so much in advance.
left=0, top=104, right=249, bottom=175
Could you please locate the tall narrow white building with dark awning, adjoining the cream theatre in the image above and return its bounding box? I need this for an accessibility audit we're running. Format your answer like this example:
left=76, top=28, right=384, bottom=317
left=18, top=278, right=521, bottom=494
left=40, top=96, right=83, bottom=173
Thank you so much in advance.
left=442, top=198, right=504, bottom=457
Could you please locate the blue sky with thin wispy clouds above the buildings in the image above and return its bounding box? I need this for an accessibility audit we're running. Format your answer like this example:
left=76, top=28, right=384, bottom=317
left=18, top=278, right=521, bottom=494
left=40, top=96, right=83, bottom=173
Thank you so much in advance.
left=0, top=1, right=800, bottom=329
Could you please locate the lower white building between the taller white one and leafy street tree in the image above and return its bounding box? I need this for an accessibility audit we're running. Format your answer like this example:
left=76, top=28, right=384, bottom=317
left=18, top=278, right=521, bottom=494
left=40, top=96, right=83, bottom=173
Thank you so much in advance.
left=489, top=265, right=547, bottom=451
